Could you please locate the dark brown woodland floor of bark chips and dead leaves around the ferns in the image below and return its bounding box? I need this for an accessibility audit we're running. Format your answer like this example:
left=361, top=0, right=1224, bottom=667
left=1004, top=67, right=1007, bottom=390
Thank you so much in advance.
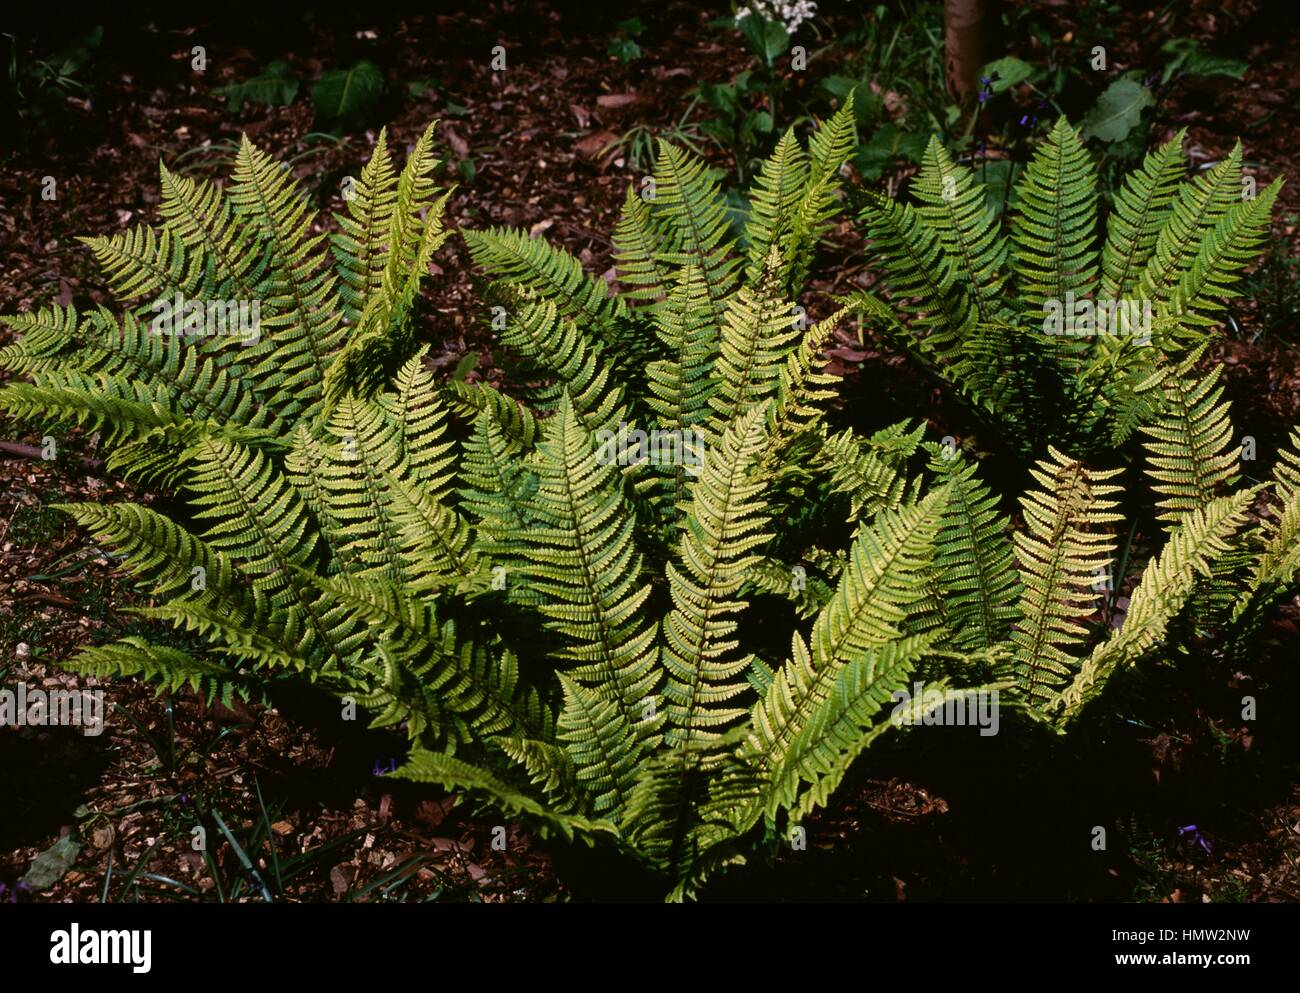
left=0, top=0, right=1300, bottom=902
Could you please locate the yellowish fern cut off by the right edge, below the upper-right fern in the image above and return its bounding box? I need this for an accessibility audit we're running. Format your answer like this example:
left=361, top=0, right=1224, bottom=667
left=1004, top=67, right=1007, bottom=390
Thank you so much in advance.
left=932, top=366, right=1300, bottom=730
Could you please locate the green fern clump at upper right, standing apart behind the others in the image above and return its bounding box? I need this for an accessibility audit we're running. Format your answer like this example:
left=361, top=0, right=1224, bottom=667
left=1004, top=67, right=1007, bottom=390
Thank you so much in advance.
left=858, top=118, right=1282, bottom=455
